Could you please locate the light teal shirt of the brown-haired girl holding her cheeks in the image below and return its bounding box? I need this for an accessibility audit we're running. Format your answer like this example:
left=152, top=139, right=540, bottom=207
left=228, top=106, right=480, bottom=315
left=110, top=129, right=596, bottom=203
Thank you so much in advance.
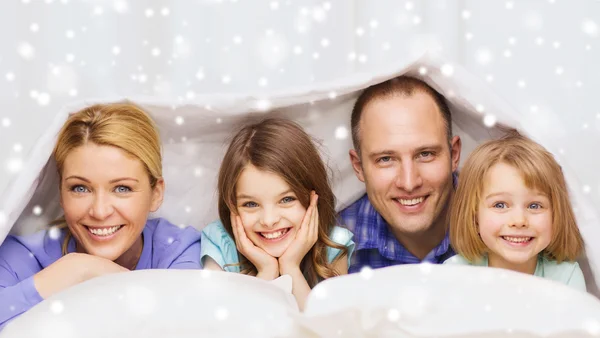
left=200, top=221, right=354, bottom=273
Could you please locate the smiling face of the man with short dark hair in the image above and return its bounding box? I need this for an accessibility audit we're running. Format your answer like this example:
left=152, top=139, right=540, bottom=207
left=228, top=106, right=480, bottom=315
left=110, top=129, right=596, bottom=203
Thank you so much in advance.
left=350, top=92, right=461, bottom=234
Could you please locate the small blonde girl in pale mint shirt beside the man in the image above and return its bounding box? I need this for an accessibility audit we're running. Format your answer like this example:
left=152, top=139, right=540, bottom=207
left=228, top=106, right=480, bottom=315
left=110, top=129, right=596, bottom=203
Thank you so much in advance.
left=445, top=131, right=586, bottom=291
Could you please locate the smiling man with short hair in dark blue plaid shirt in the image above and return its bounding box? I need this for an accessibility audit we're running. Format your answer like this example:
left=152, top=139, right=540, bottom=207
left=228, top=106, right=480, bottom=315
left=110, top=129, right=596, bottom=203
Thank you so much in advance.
left=340, top=76, right=461, bottom=273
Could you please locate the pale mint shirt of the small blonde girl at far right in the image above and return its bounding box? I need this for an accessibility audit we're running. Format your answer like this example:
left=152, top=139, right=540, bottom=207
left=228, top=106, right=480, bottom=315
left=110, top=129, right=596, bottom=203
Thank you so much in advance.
left=444, top=255, right=586, bottom=292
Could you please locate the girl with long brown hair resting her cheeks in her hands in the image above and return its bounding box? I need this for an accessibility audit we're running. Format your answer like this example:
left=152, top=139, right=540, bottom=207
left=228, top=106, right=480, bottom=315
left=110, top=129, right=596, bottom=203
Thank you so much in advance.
left=201, top=118, right=354, bottom=309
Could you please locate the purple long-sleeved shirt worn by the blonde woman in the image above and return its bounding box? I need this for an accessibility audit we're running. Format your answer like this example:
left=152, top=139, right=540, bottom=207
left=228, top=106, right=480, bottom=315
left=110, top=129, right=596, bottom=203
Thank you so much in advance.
left=0, top=218, right=200, bottom=329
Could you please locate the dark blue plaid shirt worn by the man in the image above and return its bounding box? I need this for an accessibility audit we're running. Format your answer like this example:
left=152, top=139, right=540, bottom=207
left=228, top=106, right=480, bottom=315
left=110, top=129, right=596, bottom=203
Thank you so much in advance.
left=340, top=174, right=457, bottom=273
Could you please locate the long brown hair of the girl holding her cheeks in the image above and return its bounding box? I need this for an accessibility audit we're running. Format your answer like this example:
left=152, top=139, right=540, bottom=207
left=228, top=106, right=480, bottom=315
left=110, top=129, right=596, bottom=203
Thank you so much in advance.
left=218, top=118, right=348, bottom=287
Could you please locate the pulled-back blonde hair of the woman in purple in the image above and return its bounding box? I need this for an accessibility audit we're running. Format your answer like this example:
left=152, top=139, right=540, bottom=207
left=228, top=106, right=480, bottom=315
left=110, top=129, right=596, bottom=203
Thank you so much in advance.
left=52, top=102, right=162, bottom=254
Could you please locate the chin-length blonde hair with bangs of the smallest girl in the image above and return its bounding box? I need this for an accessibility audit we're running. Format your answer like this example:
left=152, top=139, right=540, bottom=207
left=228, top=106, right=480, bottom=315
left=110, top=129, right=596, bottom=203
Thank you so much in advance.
left=450, top=130, right=583, bottom=262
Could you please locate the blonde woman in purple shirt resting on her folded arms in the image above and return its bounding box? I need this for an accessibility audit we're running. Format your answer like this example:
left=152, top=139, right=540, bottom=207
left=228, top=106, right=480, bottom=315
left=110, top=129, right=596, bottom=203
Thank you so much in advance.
left=0, top=103, right=200, bottom=328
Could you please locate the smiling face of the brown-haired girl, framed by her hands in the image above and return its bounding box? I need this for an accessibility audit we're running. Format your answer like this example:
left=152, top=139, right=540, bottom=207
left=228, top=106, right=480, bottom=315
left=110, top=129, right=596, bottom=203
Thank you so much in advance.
left=235, top=164, right=306, bottom=257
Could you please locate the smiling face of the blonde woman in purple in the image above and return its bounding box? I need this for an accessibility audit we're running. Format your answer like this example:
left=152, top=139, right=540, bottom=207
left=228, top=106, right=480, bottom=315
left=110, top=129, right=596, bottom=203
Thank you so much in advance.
left=60, top=143, right=163, bottom=261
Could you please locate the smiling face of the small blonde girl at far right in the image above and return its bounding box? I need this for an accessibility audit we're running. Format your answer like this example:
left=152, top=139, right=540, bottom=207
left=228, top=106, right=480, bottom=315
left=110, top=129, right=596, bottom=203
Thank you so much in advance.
left=477, top=163, right=552, bottom=270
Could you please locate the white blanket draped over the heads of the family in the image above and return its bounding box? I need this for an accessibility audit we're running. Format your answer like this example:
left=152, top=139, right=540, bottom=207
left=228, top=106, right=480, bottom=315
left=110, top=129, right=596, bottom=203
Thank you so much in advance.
left=0, top=56, right=600, bottom=295
